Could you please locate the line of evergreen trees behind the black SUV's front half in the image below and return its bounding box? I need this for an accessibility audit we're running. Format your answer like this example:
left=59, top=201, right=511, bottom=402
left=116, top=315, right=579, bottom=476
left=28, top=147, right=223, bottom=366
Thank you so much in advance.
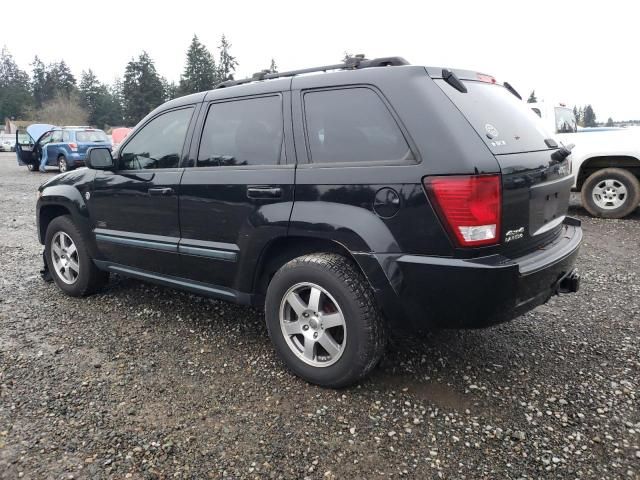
left=0, top=35, right=277, bottom=128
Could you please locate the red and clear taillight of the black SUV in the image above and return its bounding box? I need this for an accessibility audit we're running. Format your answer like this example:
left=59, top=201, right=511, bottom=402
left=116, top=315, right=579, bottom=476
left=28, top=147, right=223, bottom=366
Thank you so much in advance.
left=424, top=175, right=502, bottom=247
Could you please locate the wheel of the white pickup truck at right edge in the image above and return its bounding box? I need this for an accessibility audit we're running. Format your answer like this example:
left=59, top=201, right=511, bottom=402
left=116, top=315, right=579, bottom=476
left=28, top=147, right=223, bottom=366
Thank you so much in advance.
left=581, top=168, right=640, bottom=218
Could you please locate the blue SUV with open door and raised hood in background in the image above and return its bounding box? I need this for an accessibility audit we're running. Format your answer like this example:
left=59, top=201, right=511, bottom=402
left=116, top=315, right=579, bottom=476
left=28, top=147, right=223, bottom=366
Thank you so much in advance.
left=16, top=123, right=111, bottom=172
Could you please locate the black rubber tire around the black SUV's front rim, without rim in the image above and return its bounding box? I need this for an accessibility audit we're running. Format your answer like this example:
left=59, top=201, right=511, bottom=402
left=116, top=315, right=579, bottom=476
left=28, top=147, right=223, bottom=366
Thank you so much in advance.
left=45, top=215, right=92, bottom=297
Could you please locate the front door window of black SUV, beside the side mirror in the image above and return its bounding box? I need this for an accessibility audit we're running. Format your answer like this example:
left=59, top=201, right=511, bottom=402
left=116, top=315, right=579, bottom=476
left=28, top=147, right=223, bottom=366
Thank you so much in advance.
left=120, top=108, right=193, bottom=170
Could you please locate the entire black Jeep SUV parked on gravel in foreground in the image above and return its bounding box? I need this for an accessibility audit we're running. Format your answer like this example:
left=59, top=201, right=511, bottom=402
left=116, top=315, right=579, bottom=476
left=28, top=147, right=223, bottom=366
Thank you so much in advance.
left=37, top=57, right=582, bottom=387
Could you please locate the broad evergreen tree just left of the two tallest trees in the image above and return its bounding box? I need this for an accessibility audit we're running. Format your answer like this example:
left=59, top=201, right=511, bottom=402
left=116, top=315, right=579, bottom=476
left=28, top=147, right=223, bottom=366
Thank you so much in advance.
left=122, top=52, right=165, bottom=125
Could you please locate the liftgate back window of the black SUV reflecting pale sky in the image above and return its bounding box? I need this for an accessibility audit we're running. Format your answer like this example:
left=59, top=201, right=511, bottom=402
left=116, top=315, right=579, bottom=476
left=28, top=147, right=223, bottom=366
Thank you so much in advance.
left=436, top=80, right=551, bottom=155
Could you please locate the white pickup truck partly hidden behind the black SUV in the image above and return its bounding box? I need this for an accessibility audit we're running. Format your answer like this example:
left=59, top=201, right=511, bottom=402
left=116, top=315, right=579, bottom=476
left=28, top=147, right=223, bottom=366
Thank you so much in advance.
left=528, top=102, right=640, bottom=218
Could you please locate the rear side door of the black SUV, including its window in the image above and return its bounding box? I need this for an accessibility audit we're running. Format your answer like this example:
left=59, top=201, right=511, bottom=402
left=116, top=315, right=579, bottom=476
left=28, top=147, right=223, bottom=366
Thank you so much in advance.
left=179, top=90, right=295, bottom=294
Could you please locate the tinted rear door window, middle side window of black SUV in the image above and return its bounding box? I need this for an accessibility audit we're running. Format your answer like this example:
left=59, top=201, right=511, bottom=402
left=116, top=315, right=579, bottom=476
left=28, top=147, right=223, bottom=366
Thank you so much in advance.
left=198, top=96, right=284, bottom=166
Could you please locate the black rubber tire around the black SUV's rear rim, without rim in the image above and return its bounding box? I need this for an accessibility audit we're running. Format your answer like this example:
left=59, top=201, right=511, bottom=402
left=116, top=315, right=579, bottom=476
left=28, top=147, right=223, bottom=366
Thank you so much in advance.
left=265, top=264, right=367, bottom=387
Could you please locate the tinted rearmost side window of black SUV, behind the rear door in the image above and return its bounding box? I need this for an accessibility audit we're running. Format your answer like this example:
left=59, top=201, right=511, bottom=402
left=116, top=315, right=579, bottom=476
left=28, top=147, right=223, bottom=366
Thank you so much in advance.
left=304, top=88, right=413, bottom=163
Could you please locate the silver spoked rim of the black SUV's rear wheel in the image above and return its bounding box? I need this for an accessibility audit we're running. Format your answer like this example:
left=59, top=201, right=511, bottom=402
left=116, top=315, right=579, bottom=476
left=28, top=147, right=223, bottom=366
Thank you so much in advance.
left=280, top=282, right=347, bottom=367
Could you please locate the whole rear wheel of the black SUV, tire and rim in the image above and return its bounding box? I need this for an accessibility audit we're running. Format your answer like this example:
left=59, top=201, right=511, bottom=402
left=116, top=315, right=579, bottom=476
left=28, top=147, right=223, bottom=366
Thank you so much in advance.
left=265, top=253, right=386, bottom=388
